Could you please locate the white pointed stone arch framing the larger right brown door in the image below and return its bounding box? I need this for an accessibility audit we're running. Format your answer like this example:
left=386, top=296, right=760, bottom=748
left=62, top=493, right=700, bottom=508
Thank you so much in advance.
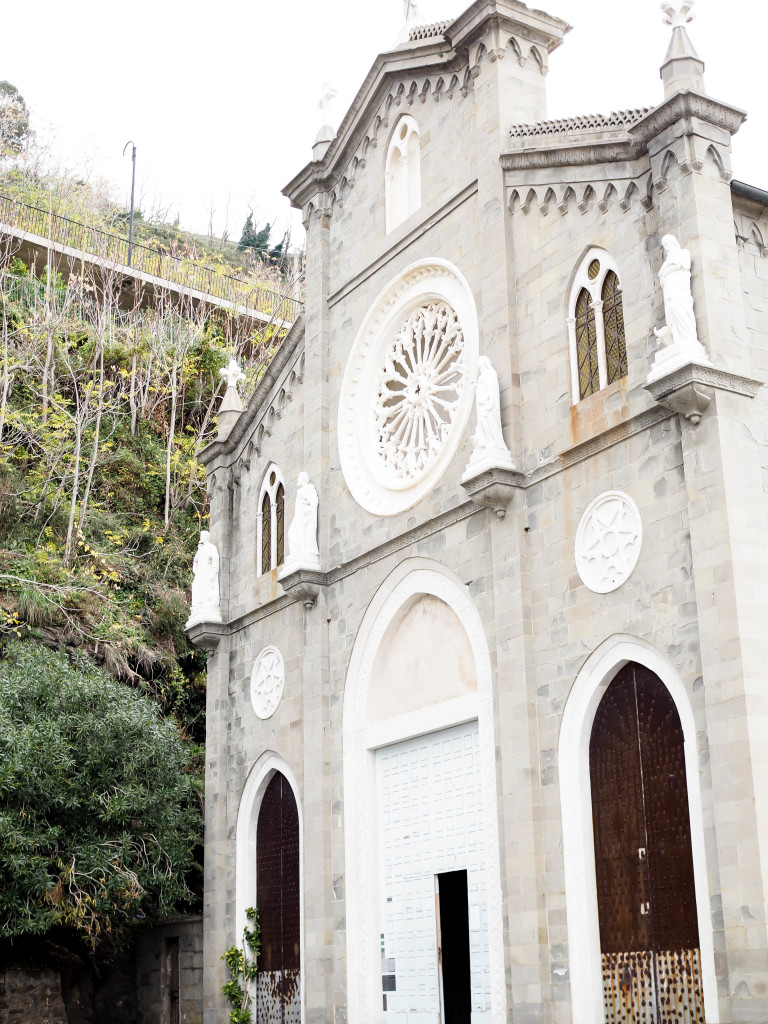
left=558, top=633, right=720, bottom=1024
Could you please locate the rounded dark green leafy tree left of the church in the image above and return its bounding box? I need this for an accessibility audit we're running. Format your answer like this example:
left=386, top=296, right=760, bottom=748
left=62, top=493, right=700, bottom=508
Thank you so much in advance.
left=0, top=641, right=202, bottom=949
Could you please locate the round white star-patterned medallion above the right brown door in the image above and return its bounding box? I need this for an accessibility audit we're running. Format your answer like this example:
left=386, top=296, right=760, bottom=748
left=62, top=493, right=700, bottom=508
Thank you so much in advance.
left=575, top=490, right=643, bottom=594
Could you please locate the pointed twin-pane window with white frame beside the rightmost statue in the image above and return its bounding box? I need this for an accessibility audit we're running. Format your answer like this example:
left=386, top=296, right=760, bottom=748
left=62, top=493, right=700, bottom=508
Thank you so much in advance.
left=567, top=249, right=628, bottom=404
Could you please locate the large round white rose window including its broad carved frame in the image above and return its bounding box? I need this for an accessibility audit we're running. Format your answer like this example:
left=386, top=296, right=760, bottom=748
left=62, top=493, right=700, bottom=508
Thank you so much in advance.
left=338, top=259, right=478, bottom=515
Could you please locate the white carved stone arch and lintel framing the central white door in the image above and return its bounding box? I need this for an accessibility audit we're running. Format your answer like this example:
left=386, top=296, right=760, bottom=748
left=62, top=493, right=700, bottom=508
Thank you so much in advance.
left=343, top=558, right=507, bottom=1024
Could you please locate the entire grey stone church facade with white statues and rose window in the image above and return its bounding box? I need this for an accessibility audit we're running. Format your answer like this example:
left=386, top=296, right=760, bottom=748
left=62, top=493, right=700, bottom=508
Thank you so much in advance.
left=188, top=0, right=768, bottom=1024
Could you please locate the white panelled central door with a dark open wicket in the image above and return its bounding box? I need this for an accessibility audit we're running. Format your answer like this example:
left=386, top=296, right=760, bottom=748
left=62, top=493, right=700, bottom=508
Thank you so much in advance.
left=376, top=722, right=490, bottom=1024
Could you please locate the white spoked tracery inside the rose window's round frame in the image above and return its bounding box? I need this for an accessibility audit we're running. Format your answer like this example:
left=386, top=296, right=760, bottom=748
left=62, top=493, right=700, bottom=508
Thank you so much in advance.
left=373, top=302, right=465, bottom=481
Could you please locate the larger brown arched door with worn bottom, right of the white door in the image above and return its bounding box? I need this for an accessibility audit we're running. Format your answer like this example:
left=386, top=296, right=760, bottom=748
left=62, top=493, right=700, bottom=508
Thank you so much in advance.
left=590, top=664, right=705, bottom=1024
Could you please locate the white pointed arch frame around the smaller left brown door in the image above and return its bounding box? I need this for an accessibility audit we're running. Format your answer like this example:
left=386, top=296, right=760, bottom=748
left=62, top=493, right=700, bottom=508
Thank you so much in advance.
left=232, top=751, right=306, bottom=1024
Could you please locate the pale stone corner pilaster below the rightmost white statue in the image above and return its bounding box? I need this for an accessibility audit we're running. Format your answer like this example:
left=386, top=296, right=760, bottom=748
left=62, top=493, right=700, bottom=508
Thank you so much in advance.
left=680, top=389, right=768, bottom=1024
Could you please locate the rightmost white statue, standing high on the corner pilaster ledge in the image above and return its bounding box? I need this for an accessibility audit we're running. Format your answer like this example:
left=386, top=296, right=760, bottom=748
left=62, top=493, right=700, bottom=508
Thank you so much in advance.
left=648, top=234, right=711, bottom=381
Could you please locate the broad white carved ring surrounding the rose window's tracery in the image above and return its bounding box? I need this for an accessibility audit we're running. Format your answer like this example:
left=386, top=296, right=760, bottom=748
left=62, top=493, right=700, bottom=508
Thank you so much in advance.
left=337, top=259, right=479, bottom=516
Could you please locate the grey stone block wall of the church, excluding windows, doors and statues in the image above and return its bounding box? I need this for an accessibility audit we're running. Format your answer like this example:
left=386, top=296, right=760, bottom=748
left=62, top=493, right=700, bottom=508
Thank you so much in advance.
left=199, top=4, right=768, bottom=1024
